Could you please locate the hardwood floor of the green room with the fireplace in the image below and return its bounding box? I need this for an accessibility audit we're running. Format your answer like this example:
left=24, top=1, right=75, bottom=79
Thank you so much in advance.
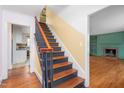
left=90, top=56, right=124, bottom=88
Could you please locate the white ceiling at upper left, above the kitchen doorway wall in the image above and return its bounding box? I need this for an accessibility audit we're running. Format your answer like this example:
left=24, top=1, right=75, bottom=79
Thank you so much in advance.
left=0, top=5, right=44, bottom=16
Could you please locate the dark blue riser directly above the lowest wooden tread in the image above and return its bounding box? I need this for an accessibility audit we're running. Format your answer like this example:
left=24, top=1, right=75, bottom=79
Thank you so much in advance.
left=49, top=72, right=77, bottom=87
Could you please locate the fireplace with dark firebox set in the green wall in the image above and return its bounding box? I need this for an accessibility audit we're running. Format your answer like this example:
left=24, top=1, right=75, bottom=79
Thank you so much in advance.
left=104, top=48, right=117, bottom=57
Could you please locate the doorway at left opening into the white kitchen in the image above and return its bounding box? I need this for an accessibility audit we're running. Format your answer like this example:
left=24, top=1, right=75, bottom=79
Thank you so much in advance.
left=11, top=24, right=30, bottom=69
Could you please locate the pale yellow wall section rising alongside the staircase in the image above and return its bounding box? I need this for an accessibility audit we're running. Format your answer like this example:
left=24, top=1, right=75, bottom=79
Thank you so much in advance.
left=46, top=7, right=85, bottom=69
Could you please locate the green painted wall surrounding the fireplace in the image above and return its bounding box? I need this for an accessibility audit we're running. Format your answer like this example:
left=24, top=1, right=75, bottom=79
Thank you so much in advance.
left=90, top=32, right=124, bottom=59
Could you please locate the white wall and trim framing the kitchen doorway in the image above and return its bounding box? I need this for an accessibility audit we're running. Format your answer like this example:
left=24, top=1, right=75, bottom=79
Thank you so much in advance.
left=1, top=10, right=35, bottom=79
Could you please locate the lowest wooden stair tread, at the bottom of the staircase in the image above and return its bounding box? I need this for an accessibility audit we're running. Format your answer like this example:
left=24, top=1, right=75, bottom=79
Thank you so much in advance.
left=56, top=77, right=84, bottom=88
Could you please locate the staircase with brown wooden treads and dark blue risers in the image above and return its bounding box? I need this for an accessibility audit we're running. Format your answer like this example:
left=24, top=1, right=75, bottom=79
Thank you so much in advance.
left=39, top=23, right=84, bottom=88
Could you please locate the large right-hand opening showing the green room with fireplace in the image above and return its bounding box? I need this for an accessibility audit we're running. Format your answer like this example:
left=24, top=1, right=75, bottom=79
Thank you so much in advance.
left=89, top=5, right=124, bottom=88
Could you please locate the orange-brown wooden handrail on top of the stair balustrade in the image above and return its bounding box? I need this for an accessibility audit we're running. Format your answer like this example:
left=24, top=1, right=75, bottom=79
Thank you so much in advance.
left=35, top=17, right=53, bottom=51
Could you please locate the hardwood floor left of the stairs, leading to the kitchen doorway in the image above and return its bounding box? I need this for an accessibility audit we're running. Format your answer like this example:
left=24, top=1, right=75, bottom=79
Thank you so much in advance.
left=0, top=66, right=41, bottom=88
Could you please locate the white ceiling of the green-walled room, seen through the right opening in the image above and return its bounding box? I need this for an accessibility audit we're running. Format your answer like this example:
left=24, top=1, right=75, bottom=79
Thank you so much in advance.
left=90, top=5, right=124, bottom=35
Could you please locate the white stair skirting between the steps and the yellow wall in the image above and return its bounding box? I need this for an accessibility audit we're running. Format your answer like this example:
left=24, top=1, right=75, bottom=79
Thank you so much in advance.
left=47, top=24, right=85, bottom=79
